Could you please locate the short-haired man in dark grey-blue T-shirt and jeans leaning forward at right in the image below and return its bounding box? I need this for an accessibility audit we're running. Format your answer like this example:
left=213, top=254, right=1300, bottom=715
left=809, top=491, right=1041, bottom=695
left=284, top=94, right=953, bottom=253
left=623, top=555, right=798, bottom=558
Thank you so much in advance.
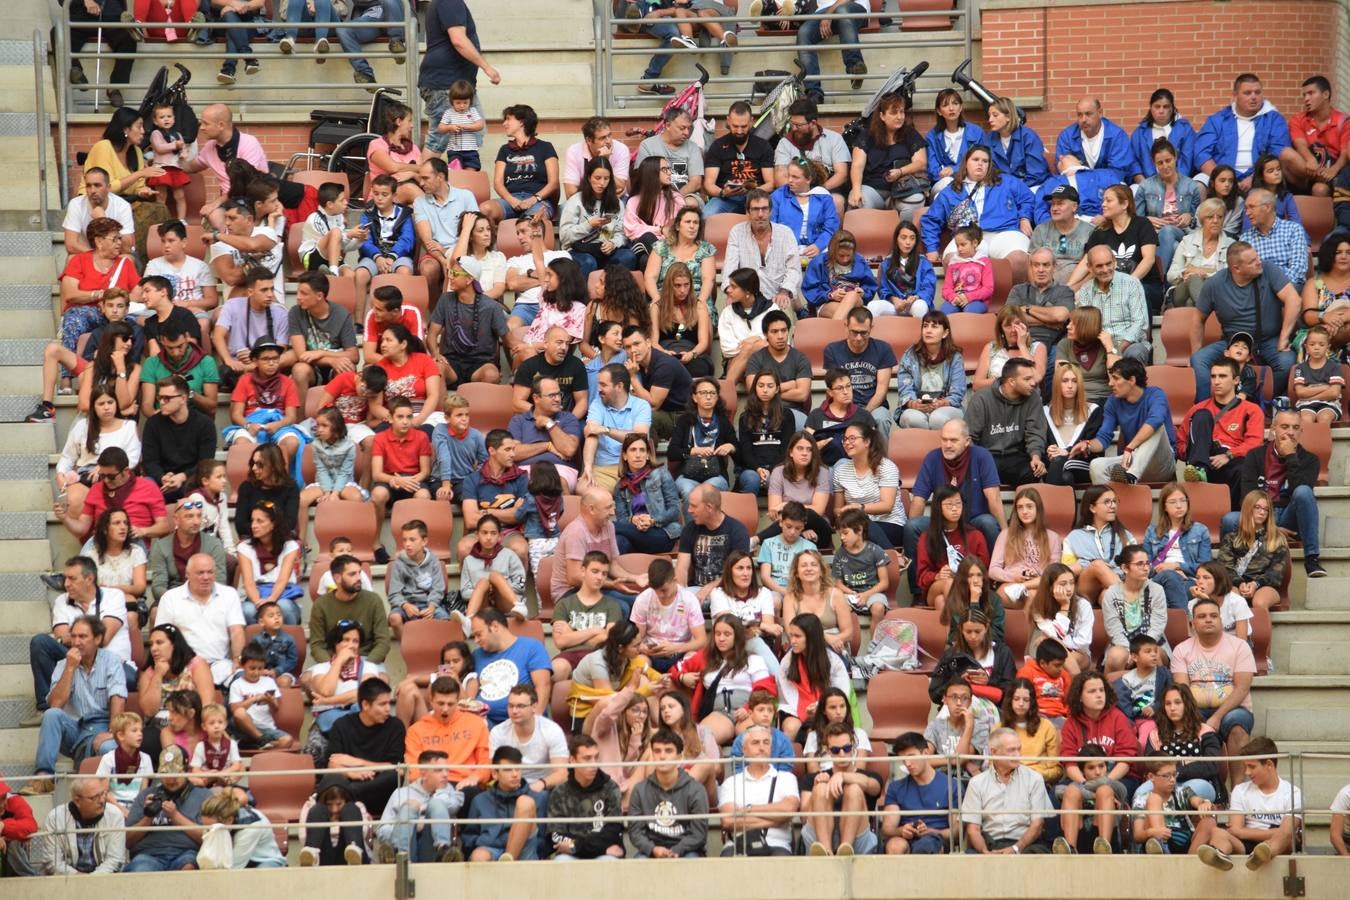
left=1191, top=240, right=1307, bottom=401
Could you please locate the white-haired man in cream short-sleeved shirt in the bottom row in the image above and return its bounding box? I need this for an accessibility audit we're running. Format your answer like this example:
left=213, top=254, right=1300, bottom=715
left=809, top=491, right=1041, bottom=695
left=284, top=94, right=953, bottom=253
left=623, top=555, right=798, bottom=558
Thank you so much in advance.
left=961, top=727, right=1054, bottom=854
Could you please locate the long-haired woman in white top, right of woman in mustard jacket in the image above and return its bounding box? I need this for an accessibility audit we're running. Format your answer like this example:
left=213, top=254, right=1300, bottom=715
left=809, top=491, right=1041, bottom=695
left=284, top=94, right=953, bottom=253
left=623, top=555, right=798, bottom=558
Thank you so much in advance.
left=667, top=613, right=775, bottom=746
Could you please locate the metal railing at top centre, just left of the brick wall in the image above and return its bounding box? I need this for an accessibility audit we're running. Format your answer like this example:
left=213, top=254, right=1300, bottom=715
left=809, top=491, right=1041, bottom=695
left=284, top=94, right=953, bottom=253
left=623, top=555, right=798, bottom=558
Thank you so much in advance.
left=594, top=3, right=972, bottom=115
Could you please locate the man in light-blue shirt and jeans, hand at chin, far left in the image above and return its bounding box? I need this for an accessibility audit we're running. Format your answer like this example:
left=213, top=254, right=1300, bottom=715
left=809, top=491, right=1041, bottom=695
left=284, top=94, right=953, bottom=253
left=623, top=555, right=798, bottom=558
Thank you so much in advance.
left=20, top=615, right=127, bottom=796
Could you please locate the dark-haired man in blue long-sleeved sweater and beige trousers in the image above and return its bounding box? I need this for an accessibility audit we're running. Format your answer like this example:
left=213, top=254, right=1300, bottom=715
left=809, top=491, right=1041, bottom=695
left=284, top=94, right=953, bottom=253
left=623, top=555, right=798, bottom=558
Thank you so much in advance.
left=1069, top=359, right=1177, bottom=484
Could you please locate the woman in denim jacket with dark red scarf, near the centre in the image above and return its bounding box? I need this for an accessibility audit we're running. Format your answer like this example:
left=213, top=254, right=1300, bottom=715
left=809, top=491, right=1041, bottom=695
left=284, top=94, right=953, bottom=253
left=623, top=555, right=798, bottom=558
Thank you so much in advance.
left=614, top=432, right=683, bottom=553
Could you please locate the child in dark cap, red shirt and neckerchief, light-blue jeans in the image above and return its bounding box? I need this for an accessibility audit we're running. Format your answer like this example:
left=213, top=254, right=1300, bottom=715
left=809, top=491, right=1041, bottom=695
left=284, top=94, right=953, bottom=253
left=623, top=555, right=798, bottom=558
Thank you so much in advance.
left=221, top=337, right=309, bottom=466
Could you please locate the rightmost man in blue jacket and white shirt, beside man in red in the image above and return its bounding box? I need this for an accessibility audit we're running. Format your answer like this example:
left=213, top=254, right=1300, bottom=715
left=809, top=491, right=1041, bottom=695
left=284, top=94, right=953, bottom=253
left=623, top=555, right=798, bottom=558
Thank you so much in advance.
left=1193, top=72, right=1289, bottom=192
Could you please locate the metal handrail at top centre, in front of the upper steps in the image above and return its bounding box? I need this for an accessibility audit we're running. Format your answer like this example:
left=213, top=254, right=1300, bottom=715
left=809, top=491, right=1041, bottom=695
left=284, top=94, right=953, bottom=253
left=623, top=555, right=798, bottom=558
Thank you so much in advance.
left=595, top=3, right=972, bottom=113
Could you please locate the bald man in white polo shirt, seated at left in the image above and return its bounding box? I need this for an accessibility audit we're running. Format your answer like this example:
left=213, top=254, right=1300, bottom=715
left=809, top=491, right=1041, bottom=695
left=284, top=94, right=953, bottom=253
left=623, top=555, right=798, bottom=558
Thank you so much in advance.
left=155, top=553, right=244, bottom=684
